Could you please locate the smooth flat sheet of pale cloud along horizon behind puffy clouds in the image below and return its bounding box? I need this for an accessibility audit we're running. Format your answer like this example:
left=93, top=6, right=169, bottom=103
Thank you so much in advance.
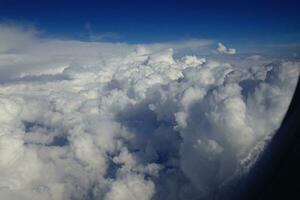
left=0, top=24, right=211, bottom=82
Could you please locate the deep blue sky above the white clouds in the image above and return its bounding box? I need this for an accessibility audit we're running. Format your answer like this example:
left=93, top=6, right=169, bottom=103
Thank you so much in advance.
left=0, top=0, right=300, bottom=52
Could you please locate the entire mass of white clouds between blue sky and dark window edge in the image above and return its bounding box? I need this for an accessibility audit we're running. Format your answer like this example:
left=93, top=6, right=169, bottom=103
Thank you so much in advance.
left=0, top=26, right=300, bottom=200
